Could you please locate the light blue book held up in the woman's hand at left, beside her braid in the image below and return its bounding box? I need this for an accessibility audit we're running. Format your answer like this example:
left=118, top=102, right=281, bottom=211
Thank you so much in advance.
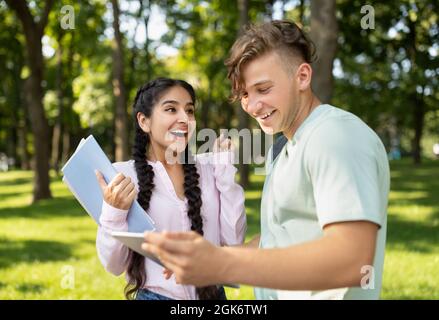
left=62, top=135, right=155, bottom=232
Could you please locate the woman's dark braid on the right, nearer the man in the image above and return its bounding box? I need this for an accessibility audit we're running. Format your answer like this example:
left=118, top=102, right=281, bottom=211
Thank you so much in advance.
left=183, top=147, right=223, bottom=300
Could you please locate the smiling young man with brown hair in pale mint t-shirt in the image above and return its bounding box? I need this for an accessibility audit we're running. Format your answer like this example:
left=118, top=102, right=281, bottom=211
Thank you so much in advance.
left=143, top=21, right=389, bottom=299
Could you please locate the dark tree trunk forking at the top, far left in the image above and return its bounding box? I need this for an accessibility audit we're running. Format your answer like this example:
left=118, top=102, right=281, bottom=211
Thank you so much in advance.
left=6, top=0, right=53, bottom=202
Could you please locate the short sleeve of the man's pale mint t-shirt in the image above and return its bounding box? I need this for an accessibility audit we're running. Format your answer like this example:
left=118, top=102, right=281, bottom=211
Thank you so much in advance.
left=304, top=119, right=385, bottom=228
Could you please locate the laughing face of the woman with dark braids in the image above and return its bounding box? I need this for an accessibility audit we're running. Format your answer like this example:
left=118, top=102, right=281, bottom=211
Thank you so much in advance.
left=138, top=86, right=195, bottom=159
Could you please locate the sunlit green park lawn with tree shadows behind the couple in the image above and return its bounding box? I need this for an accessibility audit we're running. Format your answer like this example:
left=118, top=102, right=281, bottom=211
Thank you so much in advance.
left=0, top=160, right=439, bottom=299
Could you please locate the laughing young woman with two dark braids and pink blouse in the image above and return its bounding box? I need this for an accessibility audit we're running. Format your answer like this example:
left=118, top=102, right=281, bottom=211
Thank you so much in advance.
left=96, top=78, right=246, bottom=300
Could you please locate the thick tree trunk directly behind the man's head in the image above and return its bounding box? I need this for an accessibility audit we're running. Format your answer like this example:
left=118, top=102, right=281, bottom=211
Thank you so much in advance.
left=310, top=0, right=338, bottom=103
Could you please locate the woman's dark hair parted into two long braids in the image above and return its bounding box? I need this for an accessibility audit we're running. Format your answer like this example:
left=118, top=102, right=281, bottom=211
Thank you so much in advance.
left=125, top=78, right=219, bottom=300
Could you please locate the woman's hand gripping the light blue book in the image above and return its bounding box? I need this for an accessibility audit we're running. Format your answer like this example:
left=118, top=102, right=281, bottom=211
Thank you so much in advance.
left=95, top=171, right=137, bottom=210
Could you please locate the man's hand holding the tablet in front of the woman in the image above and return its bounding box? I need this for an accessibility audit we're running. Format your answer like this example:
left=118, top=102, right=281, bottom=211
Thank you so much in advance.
left=142, top=231, right=229, bottom=286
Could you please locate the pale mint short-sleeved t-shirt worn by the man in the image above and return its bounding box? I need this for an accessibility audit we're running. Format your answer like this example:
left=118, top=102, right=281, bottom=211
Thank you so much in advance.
left=255, top=104, right=390, bottom=299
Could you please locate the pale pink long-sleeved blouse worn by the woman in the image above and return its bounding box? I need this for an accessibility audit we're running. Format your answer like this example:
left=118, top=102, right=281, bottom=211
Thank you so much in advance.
left=96, top=152, right=247, bottom=300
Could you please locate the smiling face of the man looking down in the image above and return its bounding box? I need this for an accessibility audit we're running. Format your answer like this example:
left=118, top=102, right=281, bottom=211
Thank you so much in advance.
left=241, top=52, right=299, bottom=134
